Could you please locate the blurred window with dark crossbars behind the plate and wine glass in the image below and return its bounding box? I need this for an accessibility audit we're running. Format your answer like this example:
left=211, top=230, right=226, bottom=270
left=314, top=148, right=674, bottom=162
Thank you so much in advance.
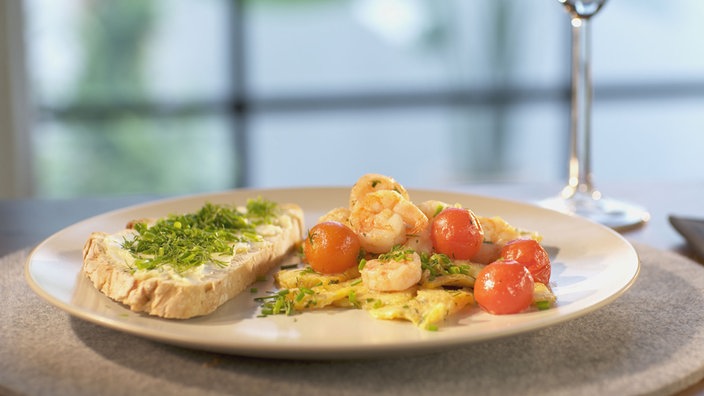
left=0, top=0, right=704, bottom=198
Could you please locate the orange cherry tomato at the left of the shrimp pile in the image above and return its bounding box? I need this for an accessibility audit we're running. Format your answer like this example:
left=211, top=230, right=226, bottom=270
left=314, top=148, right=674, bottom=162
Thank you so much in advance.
left=303, top=221, right=362, bottom=274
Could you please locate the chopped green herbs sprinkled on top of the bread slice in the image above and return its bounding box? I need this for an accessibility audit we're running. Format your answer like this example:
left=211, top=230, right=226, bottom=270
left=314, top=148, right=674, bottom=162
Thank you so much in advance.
left=122, top=198, right=278, bottom=273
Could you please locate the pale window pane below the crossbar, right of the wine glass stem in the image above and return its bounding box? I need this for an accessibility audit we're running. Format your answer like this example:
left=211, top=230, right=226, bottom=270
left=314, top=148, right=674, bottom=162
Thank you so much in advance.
left=593, top=97, right=704, bottom=182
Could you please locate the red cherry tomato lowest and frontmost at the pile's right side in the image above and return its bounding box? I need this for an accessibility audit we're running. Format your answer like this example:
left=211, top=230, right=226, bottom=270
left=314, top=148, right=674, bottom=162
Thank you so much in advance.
left=474, top=259, right=535, bottom=315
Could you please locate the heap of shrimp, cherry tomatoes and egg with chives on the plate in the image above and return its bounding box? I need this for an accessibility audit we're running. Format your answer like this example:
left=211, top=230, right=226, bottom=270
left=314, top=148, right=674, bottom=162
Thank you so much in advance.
left=256, top=174, right=556, bottom=330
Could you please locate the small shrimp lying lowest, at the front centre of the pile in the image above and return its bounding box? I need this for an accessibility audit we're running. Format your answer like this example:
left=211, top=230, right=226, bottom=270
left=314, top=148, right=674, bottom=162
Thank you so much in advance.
left=360, top=252, right=423, bottom=291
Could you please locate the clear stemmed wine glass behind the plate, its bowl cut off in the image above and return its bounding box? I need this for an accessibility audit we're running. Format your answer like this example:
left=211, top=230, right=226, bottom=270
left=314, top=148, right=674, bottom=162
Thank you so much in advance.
left=540, top=0, right=650, bottom=230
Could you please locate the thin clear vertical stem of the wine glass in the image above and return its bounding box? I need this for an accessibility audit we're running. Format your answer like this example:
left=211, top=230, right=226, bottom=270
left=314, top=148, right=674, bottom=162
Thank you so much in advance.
left=562, top=16, right=600, bottom=199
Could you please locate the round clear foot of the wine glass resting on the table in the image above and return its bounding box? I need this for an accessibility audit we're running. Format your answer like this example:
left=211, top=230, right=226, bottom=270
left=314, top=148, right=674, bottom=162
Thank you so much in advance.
left=538, top=194, right=650, bottom=231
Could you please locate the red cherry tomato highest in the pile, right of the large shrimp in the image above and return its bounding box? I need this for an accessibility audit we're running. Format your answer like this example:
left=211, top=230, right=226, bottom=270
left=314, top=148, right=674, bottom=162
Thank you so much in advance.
left=430, top=207, right=484, bottom=260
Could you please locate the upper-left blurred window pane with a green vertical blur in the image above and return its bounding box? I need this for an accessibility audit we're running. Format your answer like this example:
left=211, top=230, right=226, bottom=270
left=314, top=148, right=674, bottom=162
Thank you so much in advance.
left=26, top=0, right=232, bottom=107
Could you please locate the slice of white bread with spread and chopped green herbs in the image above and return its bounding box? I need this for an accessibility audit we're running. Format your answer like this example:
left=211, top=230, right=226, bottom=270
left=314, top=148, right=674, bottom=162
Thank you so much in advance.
left=82, top=198, right=304, bottom=319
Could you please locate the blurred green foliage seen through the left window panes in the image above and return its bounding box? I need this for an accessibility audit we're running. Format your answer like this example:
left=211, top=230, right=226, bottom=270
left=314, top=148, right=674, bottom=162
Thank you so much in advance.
left=35, top=0, right=236, bottom=196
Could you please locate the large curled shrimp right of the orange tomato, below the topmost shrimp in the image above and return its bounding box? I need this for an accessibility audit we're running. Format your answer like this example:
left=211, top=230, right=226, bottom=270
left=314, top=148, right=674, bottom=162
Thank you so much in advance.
left=350, top=190, right=428, bottom=253
